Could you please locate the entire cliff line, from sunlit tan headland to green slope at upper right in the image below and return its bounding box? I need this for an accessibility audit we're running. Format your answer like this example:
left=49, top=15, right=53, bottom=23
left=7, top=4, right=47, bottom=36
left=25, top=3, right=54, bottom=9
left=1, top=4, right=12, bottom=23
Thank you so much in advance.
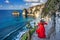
left=23, top=0, right=60, bottom=22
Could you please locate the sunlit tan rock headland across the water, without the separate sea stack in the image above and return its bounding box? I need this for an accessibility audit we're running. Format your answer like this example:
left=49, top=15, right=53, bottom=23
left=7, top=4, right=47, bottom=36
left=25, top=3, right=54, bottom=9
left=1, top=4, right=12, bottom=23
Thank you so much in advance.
left=28, top=4, right=45, bottom=18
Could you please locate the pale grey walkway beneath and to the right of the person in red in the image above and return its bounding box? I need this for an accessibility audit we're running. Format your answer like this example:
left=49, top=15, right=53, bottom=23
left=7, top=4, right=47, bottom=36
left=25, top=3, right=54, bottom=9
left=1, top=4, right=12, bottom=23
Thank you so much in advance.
left=31, top=13, right=60, bottom=40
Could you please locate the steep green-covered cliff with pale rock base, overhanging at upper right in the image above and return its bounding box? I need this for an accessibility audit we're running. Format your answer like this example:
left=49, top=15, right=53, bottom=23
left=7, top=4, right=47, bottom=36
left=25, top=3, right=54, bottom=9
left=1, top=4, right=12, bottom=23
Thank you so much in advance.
left=42, top=0, right=60, bottom=21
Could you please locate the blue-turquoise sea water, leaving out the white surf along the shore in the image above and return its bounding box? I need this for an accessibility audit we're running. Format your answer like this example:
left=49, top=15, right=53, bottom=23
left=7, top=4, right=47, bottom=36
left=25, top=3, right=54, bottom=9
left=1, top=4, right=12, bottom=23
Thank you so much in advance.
left=0, top=10, right=32, bottom=40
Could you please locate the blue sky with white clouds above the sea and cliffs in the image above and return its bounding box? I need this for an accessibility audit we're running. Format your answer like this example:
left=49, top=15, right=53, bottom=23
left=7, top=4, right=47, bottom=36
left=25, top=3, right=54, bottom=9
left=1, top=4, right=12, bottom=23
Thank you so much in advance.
left=0, top=0, right=47, bottom=10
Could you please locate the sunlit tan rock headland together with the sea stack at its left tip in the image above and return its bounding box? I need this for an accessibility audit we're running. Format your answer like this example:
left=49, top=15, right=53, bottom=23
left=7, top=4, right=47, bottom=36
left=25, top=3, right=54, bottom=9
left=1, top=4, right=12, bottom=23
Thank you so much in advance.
left=23, top=4, right=45, bottom=18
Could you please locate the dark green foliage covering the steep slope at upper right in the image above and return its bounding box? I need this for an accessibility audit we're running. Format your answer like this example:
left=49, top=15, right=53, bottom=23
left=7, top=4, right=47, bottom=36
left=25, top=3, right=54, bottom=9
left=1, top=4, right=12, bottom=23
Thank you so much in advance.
left=42, top=0, right=60, bottom=16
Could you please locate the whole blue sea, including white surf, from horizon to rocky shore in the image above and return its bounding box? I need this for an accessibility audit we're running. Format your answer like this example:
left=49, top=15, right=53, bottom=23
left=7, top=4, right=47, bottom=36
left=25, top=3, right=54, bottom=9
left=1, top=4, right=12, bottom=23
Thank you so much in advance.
left=0, top=10, right=33, bottom=40
